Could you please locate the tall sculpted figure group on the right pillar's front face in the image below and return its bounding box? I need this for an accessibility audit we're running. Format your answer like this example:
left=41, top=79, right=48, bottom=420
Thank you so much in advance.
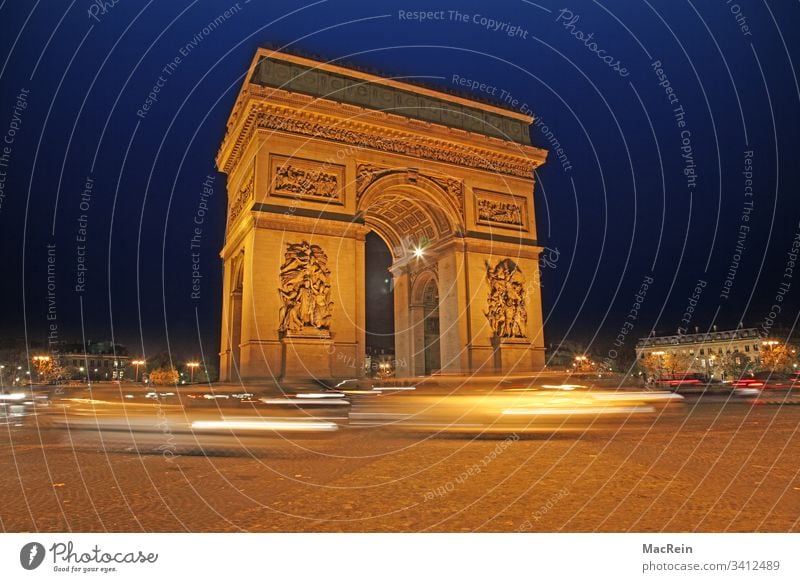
left=486, top=259, right=528, bottom=338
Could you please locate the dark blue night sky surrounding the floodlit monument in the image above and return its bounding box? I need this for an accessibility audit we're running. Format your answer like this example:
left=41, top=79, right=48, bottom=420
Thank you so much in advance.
left=0, top=0, right=800, bottom=361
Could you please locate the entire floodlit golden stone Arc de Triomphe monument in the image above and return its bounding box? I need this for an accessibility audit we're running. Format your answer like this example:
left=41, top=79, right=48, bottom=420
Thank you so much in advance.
left=217, top=50, right=545, bottom=381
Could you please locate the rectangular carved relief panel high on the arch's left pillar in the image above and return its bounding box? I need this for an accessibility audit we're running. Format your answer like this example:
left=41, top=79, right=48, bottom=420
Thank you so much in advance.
left=270, top=156, right=344, bottom=203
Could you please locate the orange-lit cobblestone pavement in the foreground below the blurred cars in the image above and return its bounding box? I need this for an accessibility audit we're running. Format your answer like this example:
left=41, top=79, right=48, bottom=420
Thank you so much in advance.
left=0, top=403, right=800, bottom=532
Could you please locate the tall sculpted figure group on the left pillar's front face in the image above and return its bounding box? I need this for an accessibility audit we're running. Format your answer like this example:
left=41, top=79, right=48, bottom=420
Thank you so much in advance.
left=278, top=241, right=333, bottom=334
